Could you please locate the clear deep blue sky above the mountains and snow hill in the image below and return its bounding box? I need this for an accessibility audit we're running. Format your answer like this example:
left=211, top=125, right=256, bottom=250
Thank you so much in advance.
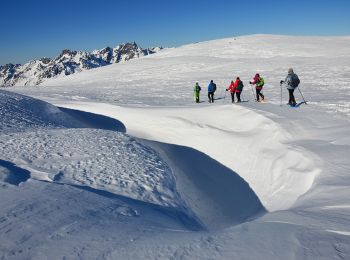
left=0, top=0, right=350, bottom=64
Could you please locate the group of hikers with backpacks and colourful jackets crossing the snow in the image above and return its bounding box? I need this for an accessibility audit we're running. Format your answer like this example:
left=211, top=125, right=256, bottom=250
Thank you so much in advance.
left=194, top=68, right=300, bottom=106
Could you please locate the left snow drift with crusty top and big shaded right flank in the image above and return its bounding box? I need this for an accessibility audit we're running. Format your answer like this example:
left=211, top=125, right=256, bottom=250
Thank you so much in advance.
left=0, top=91, right=265, bottom=229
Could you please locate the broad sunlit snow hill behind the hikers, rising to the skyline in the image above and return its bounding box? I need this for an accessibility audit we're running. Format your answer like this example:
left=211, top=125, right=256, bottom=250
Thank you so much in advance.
left=16, top=35, right=350, bottom=116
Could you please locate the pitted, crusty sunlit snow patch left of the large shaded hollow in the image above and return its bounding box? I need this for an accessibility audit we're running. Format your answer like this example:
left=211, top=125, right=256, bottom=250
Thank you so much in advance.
left=0, top=129, right=179, bottom=206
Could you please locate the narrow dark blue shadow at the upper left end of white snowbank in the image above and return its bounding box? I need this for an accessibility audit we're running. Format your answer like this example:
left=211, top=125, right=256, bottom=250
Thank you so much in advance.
left=58, top=107, right=126, bottom=133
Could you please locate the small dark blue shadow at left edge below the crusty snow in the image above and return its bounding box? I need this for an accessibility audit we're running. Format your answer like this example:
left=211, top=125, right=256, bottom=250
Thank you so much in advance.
left=0, top=159, right=30, bottom=186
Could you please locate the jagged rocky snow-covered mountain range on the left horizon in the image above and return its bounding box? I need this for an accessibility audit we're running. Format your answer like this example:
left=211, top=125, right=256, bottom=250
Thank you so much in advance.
left=0, top=42, right=162, bottom=87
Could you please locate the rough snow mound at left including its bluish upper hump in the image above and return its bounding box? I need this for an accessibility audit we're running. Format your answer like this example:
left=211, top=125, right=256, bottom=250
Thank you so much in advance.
left=0, top=91, right=183, bottom=206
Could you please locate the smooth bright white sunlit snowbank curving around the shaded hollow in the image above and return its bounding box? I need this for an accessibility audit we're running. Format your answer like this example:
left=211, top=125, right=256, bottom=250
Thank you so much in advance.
left=59, top=102, right=320, bottom=211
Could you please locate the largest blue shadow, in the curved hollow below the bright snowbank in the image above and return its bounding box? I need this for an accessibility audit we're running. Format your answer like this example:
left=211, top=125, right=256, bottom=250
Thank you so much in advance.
left=142, top=140, right=267, bottom=229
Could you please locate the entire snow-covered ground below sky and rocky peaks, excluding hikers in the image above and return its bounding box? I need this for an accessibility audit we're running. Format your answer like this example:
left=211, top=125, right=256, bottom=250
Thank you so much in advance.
left=0, top=35, right=350, bottom=259
